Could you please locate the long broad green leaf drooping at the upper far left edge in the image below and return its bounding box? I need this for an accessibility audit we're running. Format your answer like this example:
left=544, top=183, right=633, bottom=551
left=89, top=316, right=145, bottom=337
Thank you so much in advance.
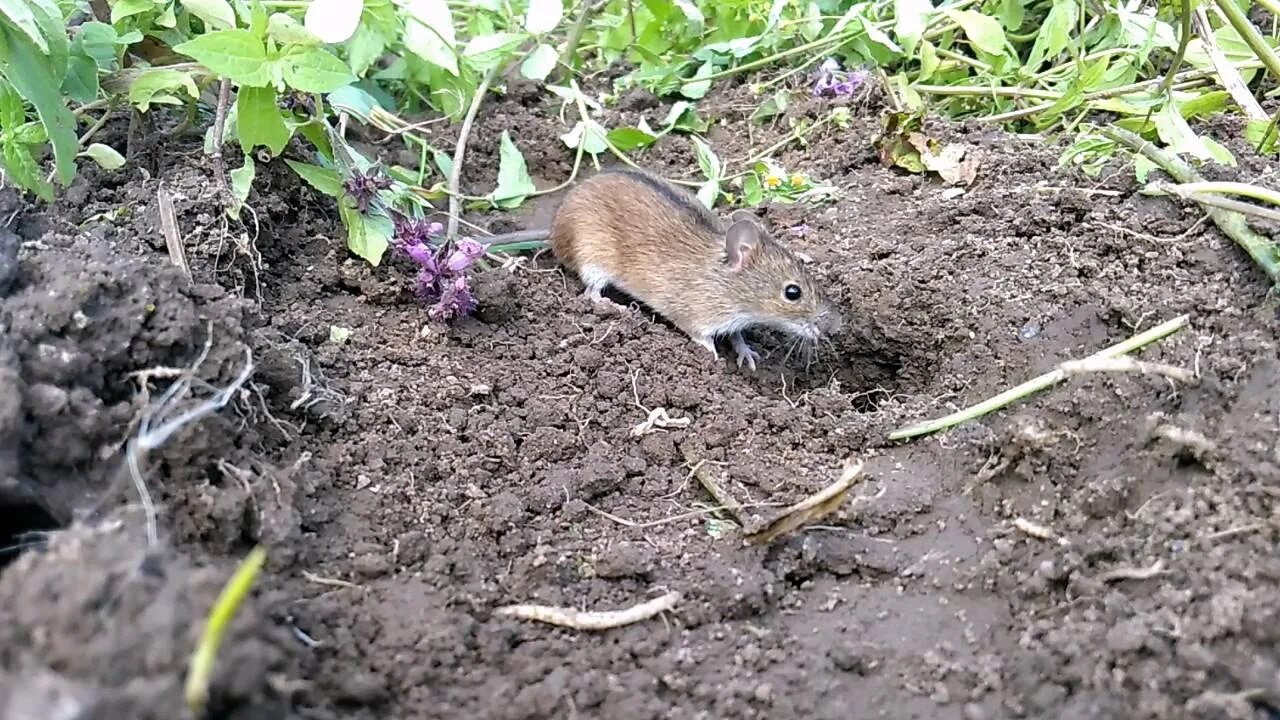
left=0, top=24, right=79, bottom=186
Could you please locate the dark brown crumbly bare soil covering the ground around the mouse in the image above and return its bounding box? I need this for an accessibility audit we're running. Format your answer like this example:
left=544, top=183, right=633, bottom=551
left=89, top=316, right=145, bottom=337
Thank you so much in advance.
left=0, top=67, right=1280, bottom=720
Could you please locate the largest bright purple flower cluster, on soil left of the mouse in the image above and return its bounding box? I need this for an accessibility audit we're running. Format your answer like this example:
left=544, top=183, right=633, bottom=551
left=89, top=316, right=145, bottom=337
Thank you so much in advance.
left=396, top=218, right=484, bottom=320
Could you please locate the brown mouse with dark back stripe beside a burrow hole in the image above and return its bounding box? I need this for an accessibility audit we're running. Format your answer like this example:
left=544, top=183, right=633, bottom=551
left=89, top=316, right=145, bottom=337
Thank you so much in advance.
left=485, top=168, right=844, bottom=372
